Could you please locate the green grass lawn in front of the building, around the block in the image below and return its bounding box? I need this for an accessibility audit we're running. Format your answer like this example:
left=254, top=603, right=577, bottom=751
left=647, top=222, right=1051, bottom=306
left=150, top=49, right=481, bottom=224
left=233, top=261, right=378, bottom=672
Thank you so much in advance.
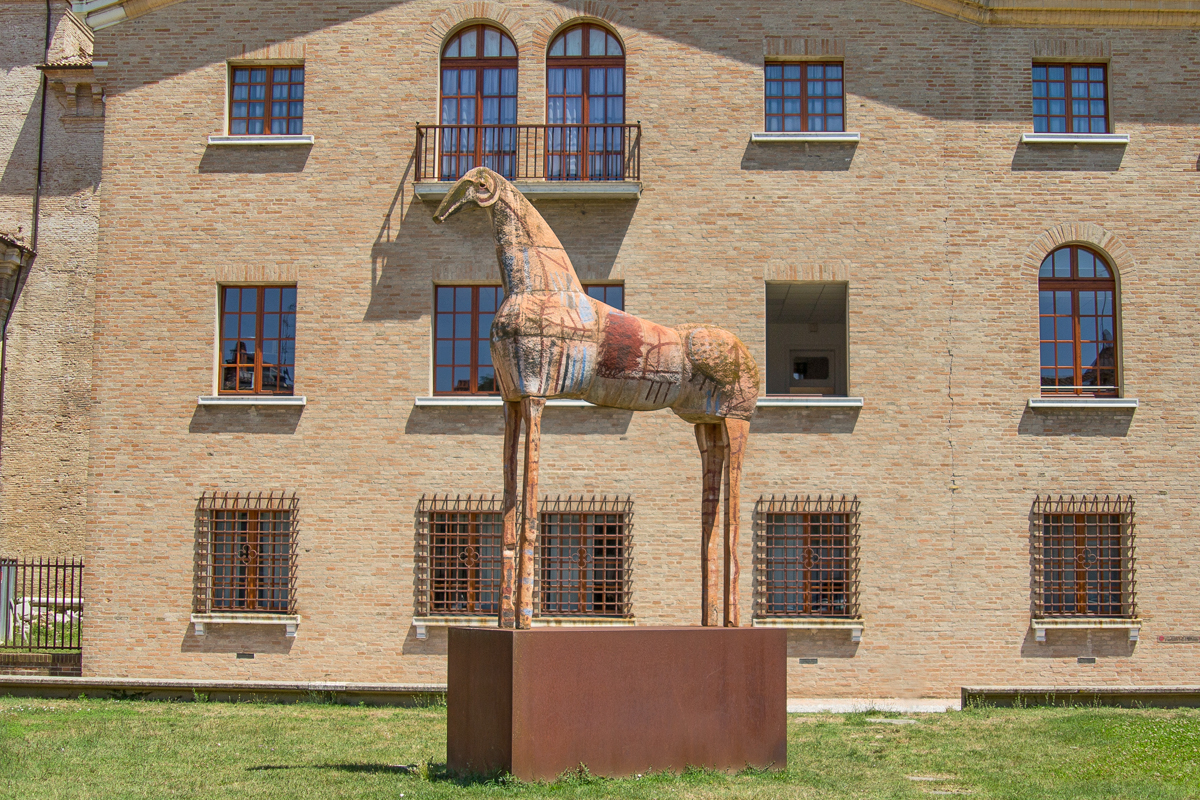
left=0, top=698, right=1200, bottom=800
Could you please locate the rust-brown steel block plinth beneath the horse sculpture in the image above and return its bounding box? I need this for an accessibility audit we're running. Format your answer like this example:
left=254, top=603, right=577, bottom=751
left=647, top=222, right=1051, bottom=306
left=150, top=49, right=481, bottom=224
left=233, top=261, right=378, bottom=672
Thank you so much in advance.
left=446, top=627, right=787, bottom=781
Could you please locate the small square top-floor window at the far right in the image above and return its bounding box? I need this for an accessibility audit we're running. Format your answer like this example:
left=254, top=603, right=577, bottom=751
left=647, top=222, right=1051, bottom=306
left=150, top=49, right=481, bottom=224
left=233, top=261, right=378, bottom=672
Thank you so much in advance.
left=1033, top=64, right=1109, bottom=133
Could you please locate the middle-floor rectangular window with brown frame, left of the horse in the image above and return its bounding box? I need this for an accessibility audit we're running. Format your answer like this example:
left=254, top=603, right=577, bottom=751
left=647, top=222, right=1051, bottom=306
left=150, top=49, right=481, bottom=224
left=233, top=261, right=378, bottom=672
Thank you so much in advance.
left=220, top=287, right=296, bottom=395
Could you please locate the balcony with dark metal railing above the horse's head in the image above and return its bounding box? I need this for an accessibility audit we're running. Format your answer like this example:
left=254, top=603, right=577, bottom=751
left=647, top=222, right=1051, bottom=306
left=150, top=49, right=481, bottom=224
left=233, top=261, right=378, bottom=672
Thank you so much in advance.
left=415, top=124, right=642, bottom=203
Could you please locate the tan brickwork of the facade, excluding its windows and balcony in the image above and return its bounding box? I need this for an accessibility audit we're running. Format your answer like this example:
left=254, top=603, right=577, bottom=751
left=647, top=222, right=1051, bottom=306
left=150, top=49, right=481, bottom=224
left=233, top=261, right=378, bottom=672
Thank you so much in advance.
left=82, top=0, right=1200, bottom=697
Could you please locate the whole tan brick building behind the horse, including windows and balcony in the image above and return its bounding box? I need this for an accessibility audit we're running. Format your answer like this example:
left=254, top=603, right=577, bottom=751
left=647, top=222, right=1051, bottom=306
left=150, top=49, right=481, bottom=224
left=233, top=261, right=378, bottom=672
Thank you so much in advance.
left=4, top=0, right=1200, bottom=698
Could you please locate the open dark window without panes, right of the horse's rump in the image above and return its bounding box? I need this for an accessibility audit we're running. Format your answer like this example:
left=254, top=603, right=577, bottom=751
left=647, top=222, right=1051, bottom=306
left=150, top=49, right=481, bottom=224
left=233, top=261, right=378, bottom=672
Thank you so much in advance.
left=767, top=282, right=850, bottom=397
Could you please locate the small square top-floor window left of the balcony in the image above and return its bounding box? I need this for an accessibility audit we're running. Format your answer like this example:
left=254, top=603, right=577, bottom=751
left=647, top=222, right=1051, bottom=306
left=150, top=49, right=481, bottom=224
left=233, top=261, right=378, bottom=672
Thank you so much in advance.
left=229, top=65, right=304, bottom=136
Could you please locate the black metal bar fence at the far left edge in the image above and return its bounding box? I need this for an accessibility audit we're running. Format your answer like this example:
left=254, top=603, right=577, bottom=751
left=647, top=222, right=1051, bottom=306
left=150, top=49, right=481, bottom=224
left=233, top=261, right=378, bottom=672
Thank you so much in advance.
left=0, top=558, right=83, bottom=651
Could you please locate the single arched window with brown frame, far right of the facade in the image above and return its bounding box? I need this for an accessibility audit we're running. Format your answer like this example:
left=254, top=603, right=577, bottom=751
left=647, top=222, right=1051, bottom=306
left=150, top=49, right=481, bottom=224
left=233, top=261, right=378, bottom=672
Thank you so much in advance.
left=1038, top=245, right=1117, bottom=397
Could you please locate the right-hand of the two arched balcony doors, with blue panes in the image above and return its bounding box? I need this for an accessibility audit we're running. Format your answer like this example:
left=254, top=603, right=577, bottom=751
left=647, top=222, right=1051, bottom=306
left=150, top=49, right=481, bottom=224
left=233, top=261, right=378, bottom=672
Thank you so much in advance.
left=546, top=23, right=626, bottom=181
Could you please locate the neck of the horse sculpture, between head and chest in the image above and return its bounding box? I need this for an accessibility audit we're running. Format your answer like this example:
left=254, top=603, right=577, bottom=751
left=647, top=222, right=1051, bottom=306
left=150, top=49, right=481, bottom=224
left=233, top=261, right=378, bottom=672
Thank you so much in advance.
left=488, top=186, right=583, bottom=295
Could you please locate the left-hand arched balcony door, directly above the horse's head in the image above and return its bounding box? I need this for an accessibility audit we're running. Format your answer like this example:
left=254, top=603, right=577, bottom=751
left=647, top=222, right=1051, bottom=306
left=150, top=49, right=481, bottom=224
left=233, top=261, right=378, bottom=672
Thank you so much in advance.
left=440, top=25, right=517, bottom=180
